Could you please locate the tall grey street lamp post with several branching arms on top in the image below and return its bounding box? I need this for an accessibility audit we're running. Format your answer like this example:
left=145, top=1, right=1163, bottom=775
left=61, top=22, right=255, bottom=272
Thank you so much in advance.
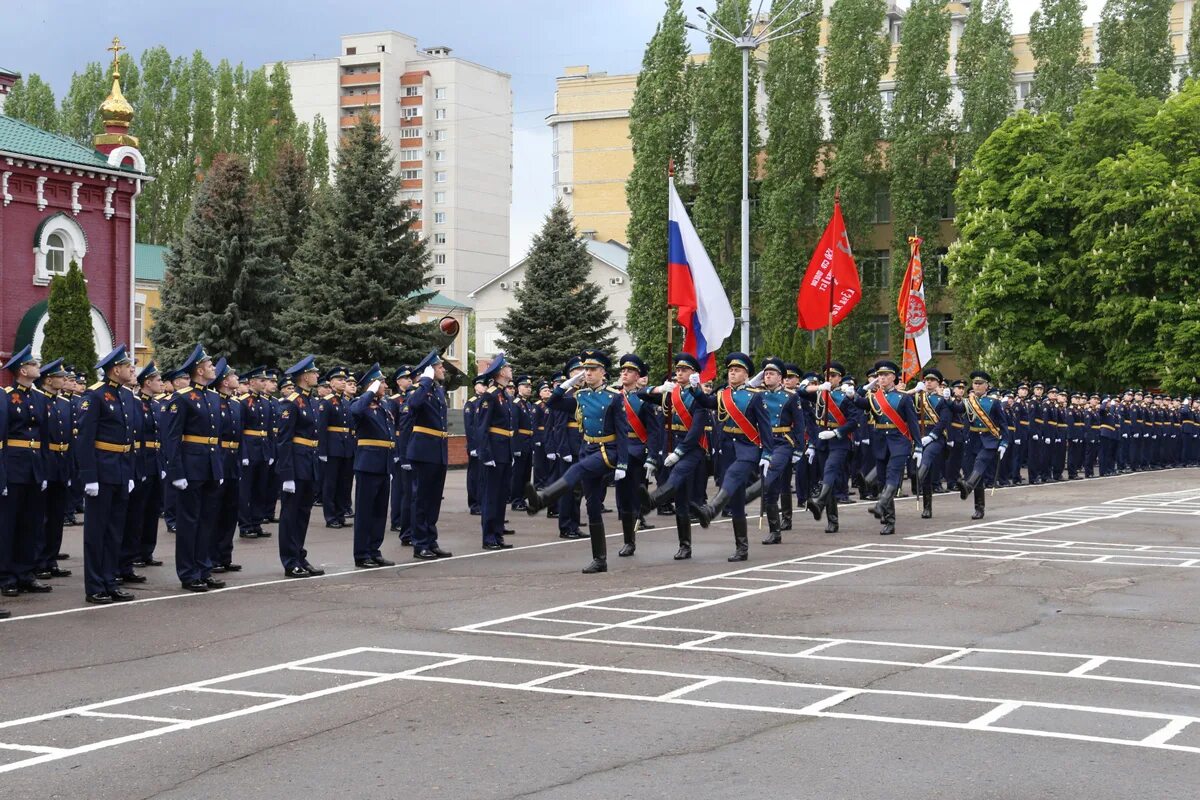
left=686, top=0, right=812, bottom=353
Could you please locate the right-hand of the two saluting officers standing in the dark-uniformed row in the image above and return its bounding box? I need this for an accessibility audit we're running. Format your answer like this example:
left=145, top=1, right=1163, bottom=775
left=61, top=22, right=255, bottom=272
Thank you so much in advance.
left=404, top=350, right=452, bottom=559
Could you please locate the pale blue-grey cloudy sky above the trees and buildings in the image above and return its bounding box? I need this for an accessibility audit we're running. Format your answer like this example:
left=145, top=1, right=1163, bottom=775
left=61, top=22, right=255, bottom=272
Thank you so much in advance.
left=0, top=0, right=1103, bottom=259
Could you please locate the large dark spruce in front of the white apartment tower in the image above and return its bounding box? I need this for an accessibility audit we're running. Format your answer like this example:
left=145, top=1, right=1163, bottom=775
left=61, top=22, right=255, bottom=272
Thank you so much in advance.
left=278, top=113, right=436, bottom=369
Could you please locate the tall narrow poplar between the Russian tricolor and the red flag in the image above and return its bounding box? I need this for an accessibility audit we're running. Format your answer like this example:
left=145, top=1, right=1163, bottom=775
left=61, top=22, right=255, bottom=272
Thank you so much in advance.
left=754, top=0, right=823, bottom=359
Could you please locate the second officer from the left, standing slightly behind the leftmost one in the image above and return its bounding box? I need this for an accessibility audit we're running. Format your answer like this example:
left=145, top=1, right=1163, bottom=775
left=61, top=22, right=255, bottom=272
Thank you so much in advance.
left=34, top=359, right=76, bottom=578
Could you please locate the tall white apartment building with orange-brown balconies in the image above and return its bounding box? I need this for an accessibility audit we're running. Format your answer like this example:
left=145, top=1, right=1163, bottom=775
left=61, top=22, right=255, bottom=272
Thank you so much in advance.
left=283, top=31, right=512, bottom=302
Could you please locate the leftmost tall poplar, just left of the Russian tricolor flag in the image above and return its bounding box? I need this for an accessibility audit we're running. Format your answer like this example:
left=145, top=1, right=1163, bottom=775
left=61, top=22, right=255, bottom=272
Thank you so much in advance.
left=625, top=0, right=690, bottom=371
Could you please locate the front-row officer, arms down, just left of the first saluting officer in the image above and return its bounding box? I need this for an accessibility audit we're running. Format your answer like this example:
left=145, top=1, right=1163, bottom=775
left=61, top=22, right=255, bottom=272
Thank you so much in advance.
left=275, top=355, right=325, bottom=578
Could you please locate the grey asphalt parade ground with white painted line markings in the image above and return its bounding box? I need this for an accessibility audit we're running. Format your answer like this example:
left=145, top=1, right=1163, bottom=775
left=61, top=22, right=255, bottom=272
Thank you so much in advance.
left=0, top=469, right=1200, bottom=800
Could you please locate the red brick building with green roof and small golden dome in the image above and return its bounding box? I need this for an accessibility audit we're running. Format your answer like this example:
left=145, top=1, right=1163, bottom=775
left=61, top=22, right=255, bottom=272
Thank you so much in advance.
left=0, top=51, right=150, bottom=367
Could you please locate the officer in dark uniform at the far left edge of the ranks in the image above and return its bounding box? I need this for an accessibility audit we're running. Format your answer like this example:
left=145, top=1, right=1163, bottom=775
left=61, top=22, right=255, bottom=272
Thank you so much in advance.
left=0, top=345, right=50, bottom=597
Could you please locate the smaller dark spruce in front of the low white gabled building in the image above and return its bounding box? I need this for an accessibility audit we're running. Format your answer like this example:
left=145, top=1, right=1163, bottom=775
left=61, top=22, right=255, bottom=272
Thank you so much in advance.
left=499, top=201, right=620, bottom=383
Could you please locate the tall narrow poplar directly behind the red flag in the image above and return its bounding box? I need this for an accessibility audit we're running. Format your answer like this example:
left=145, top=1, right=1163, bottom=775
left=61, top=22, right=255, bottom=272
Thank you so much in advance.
left=821, top=0, right=892, bottom=372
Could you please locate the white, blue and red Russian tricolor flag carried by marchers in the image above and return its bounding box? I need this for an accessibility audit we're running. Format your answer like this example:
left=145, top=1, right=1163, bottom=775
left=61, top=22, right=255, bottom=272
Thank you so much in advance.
left=667, top=179, right=734, bottom=380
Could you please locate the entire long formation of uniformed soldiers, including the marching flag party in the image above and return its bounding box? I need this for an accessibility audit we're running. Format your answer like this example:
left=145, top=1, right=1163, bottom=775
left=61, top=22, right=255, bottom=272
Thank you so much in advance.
left=0, top=344, right=1200, bottom=616
